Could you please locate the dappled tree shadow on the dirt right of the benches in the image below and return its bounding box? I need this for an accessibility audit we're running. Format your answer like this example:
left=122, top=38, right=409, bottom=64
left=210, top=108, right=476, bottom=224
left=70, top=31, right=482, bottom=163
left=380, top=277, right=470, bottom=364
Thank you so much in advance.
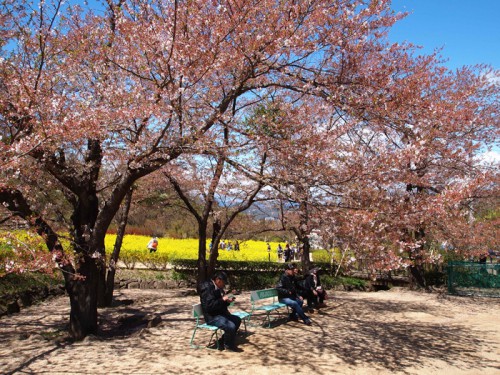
left=233, top=299, right=495, bottom=373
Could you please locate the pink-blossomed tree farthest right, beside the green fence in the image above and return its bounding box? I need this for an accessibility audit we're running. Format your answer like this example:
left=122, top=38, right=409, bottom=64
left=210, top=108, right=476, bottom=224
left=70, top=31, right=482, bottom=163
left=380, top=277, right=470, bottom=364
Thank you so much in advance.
left=288, top=61, right=499, bottom=286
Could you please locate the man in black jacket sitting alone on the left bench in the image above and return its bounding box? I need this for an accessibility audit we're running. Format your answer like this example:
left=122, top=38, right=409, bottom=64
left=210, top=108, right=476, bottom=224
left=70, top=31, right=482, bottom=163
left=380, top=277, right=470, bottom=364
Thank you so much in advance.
left=200, top=271, right=242, bottom=352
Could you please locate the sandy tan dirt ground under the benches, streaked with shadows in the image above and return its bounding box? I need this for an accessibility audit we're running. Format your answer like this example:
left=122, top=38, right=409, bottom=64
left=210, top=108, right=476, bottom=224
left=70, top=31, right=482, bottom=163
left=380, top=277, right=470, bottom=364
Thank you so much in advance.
left=0, top=288, right=500, bottom=375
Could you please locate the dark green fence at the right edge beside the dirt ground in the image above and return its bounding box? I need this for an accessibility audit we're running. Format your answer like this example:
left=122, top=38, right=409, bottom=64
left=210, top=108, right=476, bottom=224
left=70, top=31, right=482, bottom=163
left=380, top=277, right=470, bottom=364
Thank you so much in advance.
left=447, top=262, right=500, bottom=297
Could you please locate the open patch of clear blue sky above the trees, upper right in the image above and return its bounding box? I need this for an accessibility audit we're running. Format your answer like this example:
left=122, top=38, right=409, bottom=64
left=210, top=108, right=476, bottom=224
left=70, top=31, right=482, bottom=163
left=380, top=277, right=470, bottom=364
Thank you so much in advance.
left=389, top=0, right=500, bottom=69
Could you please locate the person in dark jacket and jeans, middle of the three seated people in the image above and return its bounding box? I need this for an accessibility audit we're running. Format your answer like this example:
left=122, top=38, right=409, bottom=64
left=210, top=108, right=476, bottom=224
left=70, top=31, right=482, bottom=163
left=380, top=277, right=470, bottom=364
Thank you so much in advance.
left=276, top=264, right=311, bottom=325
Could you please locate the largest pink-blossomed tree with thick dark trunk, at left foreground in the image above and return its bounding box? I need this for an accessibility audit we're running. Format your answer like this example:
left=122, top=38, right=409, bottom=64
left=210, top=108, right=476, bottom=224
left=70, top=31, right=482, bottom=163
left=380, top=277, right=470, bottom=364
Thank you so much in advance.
left=0, top=0, right=498, bottom=338
